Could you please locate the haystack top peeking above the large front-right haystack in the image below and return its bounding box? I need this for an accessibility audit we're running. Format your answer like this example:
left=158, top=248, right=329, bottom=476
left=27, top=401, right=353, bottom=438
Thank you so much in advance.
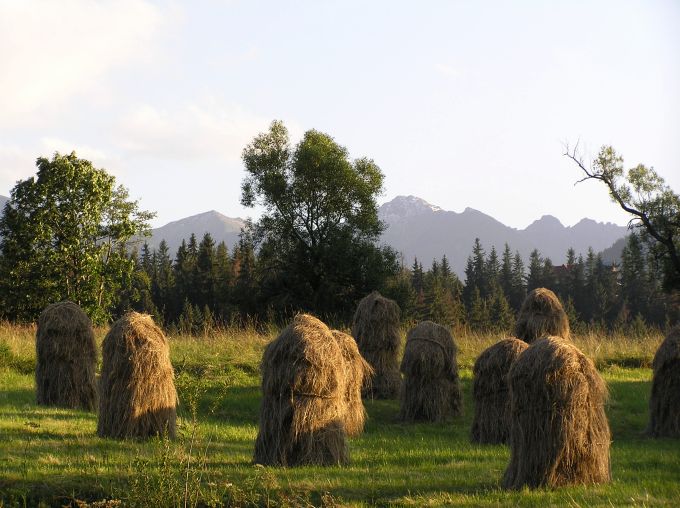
left=515, top=288, right=571, bottom=344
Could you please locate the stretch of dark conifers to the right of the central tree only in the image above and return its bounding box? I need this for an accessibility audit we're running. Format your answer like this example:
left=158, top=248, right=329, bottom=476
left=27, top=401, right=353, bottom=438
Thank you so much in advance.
left=394, top=234, right=677, bottom=332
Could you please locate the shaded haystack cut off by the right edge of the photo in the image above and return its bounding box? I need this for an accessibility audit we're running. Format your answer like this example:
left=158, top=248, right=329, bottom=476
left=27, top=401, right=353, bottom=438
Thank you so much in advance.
left=647, top=325, right=680, bottom=437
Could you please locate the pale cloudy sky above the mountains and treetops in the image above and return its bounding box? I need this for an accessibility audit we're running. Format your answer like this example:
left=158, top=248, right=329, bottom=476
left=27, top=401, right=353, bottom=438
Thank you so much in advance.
left=0, top=0, right=680, bottom=228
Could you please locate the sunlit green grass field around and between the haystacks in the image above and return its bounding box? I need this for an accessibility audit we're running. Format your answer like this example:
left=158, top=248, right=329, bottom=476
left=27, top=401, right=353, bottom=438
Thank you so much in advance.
left=0, top=325, right=680, bottom=507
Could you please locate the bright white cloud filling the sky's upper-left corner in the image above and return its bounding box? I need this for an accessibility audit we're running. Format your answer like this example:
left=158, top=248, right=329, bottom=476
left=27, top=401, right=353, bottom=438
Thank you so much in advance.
left=0, top=0, right=163, bottom=127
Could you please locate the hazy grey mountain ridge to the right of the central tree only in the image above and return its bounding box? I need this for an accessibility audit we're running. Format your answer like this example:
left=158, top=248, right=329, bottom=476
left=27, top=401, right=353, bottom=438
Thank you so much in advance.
left=378, top=196, right=628, bottom=276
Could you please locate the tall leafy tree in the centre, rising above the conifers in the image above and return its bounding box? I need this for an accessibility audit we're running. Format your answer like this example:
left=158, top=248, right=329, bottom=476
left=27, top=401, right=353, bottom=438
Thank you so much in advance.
left=241, top=121, right=398, bottom=315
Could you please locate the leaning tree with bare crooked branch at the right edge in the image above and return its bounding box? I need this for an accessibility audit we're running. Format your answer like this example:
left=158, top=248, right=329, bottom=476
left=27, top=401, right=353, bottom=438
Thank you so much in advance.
left=565, top=146, right=680, bottom=290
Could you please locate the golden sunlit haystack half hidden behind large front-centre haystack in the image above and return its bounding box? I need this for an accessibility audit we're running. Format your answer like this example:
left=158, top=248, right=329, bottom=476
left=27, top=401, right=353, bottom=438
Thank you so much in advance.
left=332, top=330, right=373, bottom=437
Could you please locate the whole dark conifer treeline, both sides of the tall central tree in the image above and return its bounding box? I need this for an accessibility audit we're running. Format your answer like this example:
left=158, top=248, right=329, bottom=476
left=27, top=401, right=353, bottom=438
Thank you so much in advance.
left=123, top=230, right=673, bottom=334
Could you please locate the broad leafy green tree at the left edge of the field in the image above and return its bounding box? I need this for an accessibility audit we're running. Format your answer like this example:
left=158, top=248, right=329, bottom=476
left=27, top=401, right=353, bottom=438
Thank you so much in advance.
left=0, top=152, right=154, bottom=322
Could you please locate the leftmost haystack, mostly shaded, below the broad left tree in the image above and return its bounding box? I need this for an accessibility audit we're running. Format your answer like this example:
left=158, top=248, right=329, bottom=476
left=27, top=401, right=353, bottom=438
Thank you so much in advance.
left=35, top=302, right=97, bottom=411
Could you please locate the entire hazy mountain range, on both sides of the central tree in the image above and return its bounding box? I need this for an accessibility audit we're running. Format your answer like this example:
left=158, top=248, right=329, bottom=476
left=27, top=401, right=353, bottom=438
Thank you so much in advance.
left=0, top=192, right=627, bottom=276
